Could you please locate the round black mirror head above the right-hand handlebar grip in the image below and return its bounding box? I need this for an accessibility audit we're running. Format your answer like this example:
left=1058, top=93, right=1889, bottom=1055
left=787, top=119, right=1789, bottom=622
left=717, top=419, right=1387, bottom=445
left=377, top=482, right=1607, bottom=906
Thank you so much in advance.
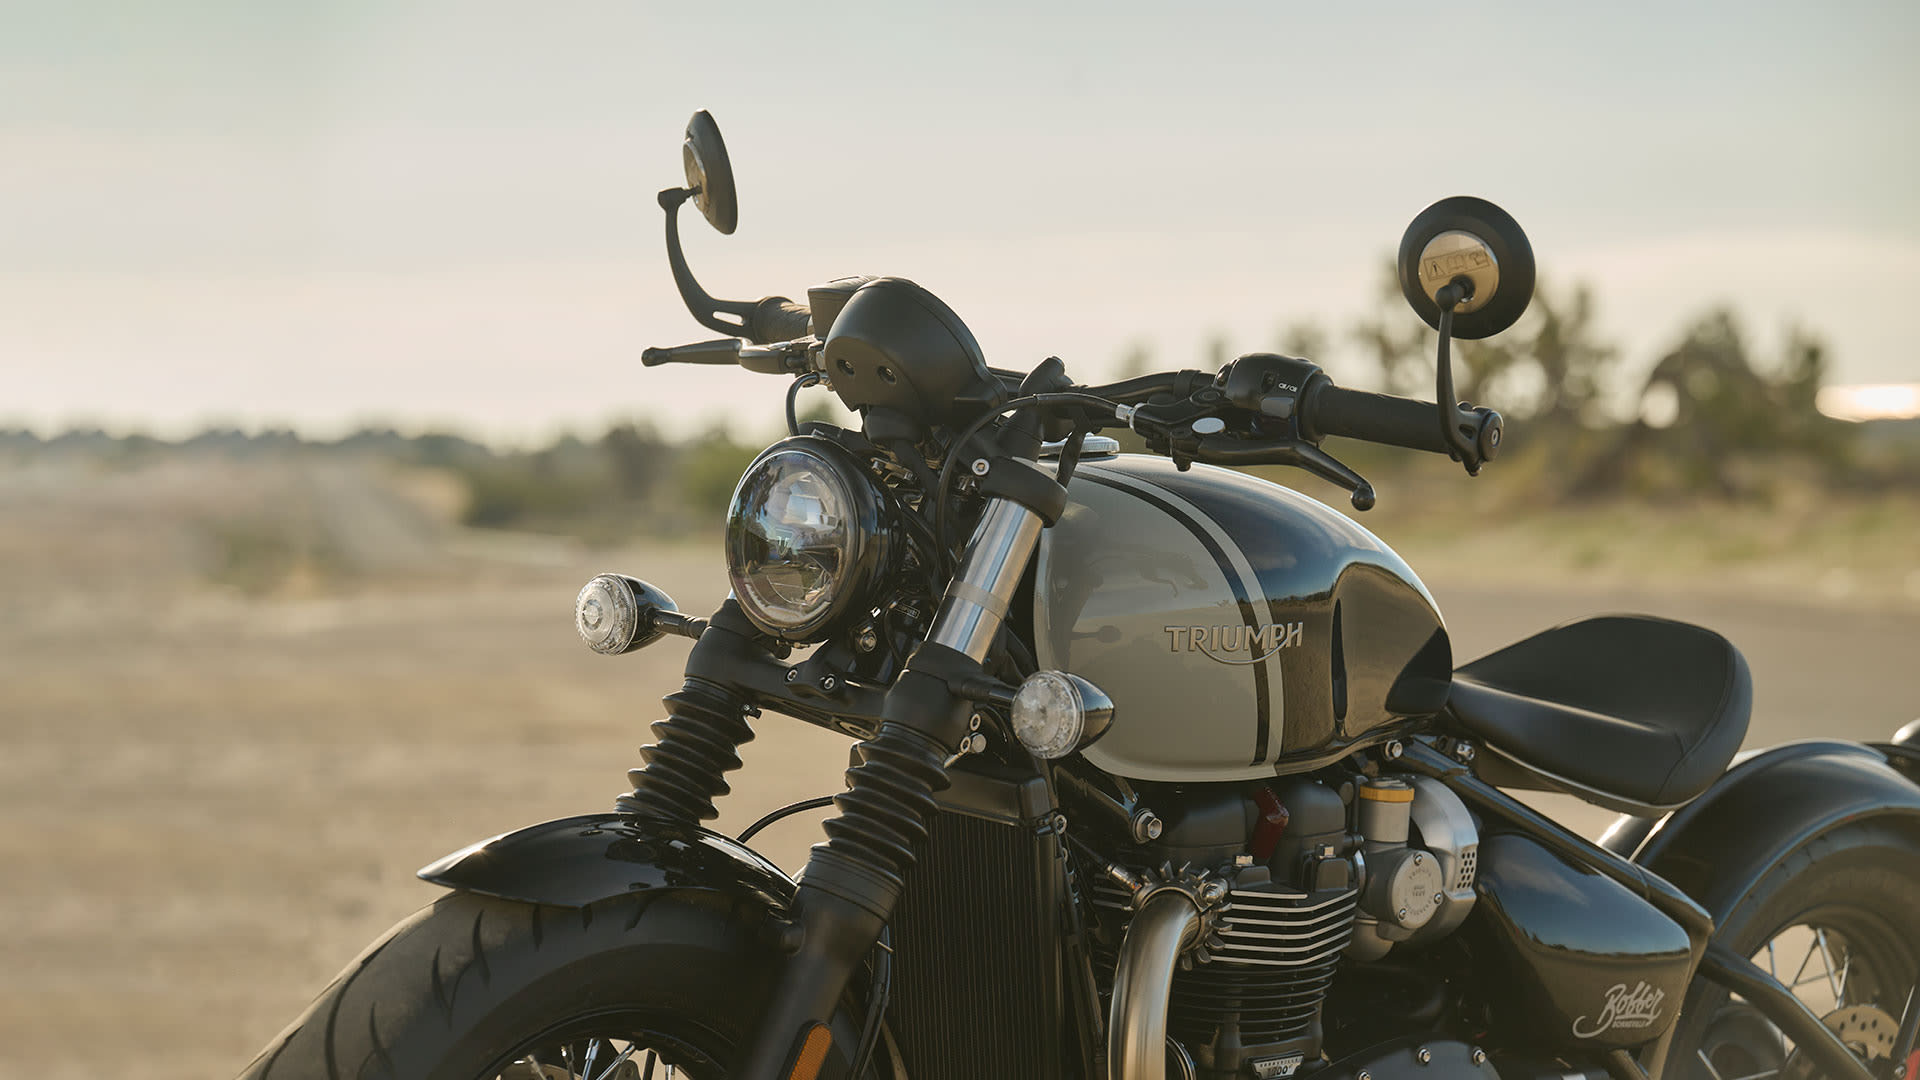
left=1400, top=194, right=1534, bottom=340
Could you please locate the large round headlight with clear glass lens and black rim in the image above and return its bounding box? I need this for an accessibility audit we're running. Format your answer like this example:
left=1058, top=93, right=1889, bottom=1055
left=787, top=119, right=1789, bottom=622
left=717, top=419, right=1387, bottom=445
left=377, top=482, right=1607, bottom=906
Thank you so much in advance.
left=726, top=434, right=889, bottom=642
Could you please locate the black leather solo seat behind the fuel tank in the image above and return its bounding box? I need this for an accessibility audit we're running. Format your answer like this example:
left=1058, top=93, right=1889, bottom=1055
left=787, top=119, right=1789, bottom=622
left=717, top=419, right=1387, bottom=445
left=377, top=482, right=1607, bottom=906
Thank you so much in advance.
left=1448, top=615, right=1753, bottom=807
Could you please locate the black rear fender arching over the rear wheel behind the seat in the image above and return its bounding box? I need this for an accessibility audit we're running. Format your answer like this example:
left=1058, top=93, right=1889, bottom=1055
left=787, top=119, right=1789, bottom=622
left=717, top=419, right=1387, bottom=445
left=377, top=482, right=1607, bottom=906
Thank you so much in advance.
left=1634, top=740, right=1920, bottom=924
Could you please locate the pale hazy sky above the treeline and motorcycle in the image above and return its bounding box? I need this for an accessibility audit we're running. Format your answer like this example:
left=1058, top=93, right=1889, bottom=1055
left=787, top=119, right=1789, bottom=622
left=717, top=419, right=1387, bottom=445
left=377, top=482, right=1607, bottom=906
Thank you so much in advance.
left=0, top=0, right=1920, bottom=438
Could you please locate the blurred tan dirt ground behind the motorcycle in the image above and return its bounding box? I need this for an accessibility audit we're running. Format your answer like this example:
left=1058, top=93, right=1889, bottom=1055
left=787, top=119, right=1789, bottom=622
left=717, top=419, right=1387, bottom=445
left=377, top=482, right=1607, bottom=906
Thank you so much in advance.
left=0, top=474, right=1920, bottom=1080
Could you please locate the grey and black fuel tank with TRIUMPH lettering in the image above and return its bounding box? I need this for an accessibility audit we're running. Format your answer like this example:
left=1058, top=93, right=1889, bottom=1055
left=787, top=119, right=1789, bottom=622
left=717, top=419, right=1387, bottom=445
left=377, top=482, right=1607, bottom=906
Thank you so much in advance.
left=1033, top=455, right=1453, bottom=782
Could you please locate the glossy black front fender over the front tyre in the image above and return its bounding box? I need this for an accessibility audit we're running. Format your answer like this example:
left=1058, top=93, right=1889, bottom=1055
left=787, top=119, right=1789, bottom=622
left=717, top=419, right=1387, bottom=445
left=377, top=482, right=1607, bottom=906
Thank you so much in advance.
left=420, top=813, right=793, bottom=915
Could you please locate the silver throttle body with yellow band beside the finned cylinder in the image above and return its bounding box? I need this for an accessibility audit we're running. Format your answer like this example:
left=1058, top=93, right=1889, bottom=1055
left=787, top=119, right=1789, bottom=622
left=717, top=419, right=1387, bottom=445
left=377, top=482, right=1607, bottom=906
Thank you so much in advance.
left=1346, top=776, right=1446, bottom=961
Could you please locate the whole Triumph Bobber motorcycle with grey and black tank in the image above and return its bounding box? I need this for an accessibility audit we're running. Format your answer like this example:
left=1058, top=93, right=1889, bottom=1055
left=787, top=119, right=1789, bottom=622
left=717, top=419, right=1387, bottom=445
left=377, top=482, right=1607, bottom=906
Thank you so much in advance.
left=246, top=113, right=1920, bottom=1080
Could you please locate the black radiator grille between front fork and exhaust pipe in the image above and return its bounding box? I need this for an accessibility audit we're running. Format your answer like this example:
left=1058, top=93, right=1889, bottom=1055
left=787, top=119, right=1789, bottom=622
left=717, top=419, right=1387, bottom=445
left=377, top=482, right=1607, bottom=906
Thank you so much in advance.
left=887, top=811, right=1066, bottom=1080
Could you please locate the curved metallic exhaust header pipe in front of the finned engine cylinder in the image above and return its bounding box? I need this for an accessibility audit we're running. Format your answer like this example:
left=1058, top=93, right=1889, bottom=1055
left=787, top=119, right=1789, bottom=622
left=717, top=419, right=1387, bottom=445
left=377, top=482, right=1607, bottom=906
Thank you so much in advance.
left=1106, top=888, right=1200, bottom=1080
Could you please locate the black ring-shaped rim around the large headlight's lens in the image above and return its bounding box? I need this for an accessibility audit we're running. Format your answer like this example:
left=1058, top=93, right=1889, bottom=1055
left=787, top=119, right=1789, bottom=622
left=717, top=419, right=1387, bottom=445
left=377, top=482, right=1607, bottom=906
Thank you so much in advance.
left=722, top=434, right=899, bottom=646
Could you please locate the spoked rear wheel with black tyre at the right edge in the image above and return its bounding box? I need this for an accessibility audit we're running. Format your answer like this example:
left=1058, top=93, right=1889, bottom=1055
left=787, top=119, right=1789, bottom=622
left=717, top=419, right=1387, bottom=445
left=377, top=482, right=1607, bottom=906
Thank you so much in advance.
left=1667, top=822, right=1920, bottom=1080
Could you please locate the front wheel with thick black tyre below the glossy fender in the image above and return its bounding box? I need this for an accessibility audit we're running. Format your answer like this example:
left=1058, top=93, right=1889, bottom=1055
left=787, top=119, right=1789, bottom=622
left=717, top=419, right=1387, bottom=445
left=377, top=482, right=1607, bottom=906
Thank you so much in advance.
left=242, top=892, right=872, bottom=1080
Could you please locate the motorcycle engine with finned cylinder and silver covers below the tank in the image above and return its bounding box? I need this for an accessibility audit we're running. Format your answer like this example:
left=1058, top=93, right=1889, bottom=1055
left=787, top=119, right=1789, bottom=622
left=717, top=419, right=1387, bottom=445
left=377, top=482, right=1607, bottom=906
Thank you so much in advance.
left=1069, top=760, right=1478, bottom=1080
